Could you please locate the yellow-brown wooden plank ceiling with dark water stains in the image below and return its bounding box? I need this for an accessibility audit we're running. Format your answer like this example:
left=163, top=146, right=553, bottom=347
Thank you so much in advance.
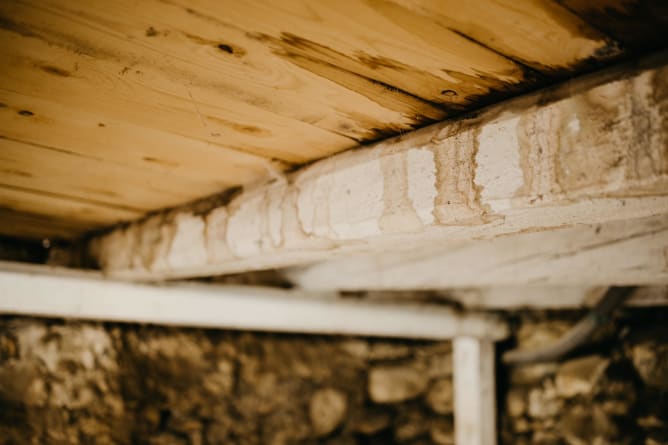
left=0, top=0, right=668, bottom=238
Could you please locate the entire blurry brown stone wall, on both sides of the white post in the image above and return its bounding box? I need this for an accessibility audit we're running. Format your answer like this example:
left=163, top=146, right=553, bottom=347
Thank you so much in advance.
left=0, top=310, right=668, bottom=445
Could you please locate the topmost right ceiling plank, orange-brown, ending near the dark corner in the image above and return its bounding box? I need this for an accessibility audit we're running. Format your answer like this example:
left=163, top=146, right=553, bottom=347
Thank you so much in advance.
left=386, top=0, right=620, bottom=69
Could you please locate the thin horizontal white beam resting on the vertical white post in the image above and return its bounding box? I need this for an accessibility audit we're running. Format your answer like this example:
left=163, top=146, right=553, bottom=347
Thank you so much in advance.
left=0, top=267, right=507, bottom=340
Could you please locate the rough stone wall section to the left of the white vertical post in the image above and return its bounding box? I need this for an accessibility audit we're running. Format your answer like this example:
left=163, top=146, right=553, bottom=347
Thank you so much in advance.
left=0, top=318, right=453, bottom=445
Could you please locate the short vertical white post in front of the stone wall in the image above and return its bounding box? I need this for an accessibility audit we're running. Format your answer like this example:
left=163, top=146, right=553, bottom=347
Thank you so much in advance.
left=453, top=337, right=496, bottom=445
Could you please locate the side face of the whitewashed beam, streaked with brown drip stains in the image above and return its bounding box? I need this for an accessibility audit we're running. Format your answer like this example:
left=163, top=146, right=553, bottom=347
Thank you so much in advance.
left=89, top=54, right=668, bottom=280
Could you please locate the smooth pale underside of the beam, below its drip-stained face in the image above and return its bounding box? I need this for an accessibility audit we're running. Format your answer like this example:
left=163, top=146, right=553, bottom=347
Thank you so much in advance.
left=285, top=214, right=668, bottom=290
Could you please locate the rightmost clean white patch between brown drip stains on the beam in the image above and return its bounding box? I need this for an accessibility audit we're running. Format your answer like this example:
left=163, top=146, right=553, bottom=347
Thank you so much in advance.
left=475, top=116, right=524, bottom=211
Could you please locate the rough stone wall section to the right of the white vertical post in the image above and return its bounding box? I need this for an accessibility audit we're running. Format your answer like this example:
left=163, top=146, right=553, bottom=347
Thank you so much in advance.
left=500, top=308, right=668, bottom=445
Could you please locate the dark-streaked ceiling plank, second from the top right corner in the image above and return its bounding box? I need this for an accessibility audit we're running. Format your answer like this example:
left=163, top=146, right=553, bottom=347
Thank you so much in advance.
left=175, top=0, right=523, bottom=109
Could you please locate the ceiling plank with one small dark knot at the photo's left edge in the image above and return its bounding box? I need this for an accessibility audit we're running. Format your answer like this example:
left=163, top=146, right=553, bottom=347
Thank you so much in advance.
left=0, top=89, right=272, bottom=186
